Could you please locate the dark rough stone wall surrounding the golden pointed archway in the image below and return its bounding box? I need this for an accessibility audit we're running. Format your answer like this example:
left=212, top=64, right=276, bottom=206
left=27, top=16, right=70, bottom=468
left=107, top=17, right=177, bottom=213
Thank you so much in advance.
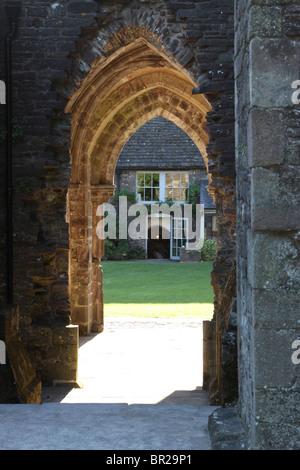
left=0, top=0, right=235, bottom=396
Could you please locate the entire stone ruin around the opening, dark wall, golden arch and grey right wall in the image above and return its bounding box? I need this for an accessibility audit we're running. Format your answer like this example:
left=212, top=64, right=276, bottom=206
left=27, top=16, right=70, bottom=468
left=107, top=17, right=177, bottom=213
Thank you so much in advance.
left=0, top=0, right=300, bottom=449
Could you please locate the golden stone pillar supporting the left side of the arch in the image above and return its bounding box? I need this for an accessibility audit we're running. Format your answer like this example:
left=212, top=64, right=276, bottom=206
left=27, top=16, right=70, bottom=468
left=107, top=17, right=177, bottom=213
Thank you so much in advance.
left=68, top=184, right=114, bottom=335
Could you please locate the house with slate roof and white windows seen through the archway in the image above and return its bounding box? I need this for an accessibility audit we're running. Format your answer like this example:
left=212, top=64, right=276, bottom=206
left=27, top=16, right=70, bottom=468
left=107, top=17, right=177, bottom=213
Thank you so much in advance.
left=110, top=116, right=216, bottom=260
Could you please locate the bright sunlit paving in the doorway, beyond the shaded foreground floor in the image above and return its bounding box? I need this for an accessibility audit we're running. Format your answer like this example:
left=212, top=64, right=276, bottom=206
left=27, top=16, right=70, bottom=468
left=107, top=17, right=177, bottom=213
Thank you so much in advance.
left=43, top=317, right=209, bottom=405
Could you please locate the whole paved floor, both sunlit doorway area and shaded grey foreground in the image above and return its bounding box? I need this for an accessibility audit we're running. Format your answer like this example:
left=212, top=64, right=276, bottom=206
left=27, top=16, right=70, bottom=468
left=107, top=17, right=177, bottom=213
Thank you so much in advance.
left=0, top=318, right=216, bottom=451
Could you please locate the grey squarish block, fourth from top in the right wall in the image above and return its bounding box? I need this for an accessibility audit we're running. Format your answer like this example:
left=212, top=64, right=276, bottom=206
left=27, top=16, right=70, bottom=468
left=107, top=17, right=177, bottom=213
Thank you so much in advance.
left=251, top=167, right=300, bottom=231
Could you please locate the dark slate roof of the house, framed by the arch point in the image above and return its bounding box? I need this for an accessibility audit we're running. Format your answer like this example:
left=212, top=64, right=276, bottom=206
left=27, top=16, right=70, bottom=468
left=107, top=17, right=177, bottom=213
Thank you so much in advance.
left=117, top=116, right=205, bottom=170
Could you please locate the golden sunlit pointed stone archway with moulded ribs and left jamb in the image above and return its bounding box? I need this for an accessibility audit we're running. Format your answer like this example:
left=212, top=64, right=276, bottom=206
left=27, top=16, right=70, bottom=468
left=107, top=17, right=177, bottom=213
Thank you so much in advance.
left=66, top=37, right=211, bottom=335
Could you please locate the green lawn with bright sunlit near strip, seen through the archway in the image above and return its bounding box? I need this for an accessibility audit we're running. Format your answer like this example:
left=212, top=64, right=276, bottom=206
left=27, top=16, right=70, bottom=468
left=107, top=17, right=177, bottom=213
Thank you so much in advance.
left=102, top=261, right=213, bottom=319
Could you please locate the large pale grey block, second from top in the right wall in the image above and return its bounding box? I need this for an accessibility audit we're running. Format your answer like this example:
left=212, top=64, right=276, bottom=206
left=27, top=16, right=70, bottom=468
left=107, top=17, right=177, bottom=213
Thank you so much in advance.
left=250, top=38, right=300, bottom=108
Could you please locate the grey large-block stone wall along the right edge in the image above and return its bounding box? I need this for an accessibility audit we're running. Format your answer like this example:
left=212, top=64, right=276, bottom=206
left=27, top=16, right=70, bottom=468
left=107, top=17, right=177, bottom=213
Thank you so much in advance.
left=235, top=0, right=300, bottom=449
